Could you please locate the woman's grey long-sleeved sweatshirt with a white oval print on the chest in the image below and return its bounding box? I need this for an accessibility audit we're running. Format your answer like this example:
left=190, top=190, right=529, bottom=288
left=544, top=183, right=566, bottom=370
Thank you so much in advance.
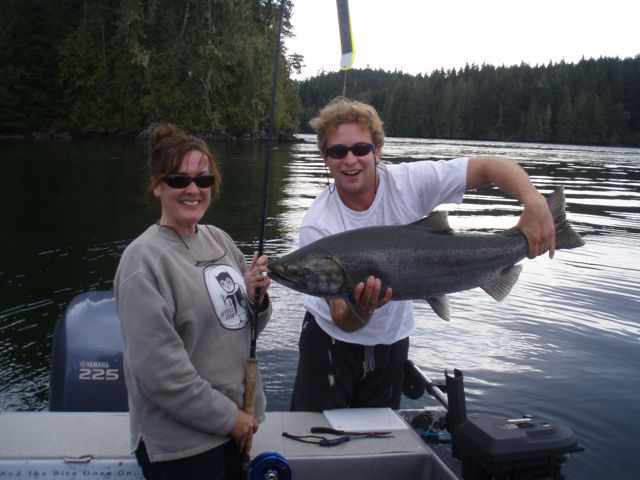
left=114, top=225, right=271, bottom=462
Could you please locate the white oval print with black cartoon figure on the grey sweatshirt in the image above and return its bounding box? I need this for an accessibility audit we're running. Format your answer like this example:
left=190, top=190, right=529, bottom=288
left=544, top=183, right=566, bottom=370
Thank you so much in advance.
left=204, top=265, right=249, bottom=330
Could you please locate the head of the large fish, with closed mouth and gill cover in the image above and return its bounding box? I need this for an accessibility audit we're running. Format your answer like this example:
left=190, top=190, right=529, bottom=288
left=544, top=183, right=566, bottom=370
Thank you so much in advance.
left=268, top=252, right=349, bottom=297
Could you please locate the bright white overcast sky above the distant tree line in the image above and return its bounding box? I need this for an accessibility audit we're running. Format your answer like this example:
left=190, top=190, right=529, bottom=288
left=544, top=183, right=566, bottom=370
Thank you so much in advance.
left=286, top=0, right=640, bottom=78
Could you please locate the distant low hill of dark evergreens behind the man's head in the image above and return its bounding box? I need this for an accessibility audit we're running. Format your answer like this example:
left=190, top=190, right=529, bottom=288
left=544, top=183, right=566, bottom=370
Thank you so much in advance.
left=299, top=55, right=640, bottom=146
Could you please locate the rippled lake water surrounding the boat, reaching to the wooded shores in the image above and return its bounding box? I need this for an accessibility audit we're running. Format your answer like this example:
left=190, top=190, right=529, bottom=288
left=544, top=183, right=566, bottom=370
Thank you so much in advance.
left=0, top=136, right=640, bottom=480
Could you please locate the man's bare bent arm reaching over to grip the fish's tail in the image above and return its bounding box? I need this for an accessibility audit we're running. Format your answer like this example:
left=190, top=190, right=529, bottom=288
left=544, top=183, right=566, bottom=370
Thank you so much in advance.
left=467, top=156, right=555, bottom=258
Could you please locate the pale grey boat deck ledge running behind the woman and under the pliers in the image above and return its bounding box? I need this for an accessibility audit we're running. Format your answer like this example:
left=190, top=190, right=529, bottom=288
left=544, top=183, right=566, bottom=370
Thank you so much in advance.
left=0, top=412, right=457, bottom=480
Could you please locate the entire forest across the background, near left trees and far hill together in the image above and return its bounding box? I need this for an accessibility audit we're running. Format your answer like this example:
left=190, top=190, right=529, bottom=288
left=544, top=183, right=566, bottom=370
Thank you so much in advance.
left=0, top=0, right=640, bottom=146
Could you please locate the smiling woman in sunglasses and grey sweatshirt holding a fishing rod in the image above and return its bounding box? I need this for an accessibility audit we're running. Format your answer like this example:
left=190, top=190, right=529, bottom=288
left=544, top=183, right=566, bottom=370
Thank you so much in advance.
left=114, top=125, right=271, bottom=480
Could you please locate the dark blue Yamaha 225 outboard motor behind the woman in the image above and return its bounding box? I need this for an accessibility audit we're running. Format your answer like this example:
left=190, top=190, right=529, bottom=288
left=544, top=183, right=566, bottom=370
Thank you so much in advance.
left=49, top=291, right=128, bottom=412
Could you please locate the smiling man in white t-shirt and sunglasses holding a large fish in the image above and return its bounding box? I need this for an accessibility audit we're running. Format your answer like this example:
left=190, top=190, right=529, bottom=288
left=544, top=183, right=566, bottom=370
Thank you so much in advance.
left=291, top=97, right=555, bottom=411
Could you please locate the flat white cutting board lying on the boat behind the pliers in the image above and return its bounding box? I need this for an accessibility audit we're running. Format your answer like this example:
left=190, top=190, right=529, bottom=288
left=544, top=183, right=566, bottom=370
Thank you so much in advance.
left=323, top=408, right=408, bottom=432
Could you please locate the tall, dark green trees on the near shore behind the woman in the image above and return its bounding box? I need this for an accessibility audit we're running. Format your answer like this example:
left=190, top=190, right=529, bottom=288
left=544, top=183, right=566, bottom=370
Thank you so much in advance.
left=0, top=0, right=300, bottom=138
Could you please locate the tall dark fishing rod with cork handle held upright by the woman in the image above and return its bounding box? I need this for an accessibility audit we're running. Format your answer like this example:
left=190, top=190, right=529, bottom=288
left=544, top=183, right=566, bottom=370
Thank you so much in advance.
left=242, top=0, right=286, bottom=475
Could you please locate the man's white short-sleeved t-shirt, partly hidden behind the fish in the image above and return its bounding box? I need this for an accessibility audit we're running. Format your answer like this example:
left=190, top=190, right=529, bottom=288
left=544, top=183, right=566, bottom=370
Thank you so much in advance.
left=299, top=157, right=468, bottom=345
